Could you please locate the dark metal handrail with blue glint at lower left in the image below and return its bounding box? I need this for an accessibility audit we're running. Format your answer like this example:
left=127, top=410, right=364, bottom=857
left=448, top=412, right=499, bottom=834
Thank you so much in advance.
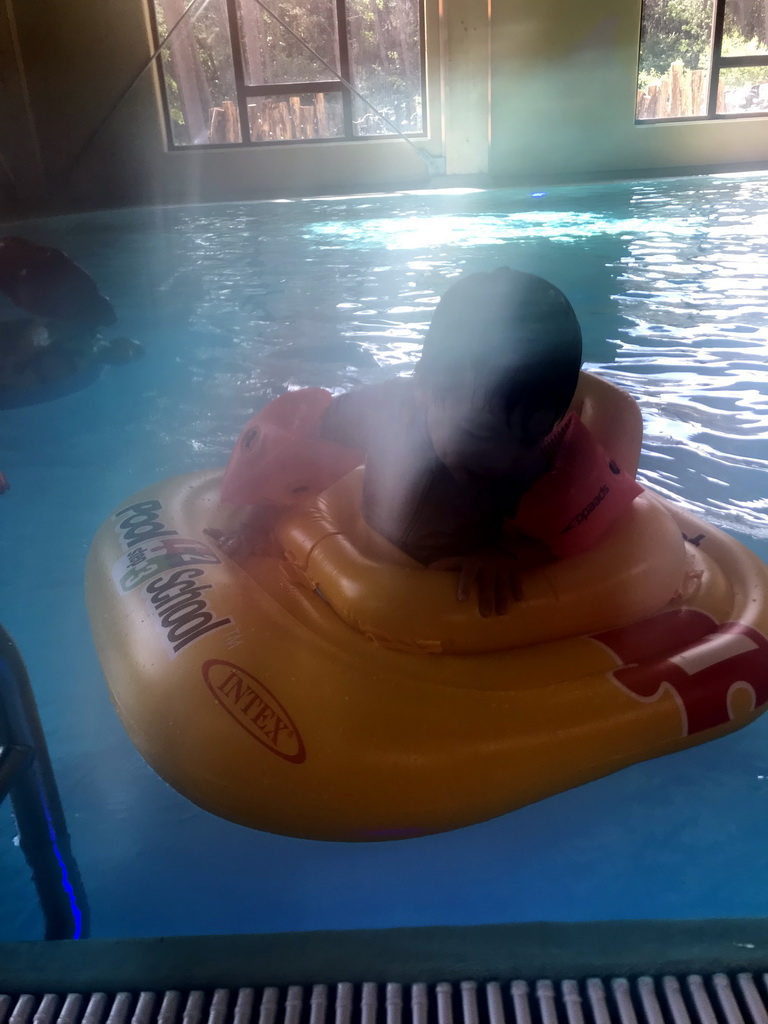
left=0, top=626, right=89, bottom=939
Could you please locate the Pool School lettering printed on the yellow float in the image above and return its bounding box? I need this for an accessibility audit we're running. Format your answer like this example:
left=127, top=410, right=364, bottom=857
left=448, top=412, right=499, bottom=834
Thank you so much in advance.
left=113, top=499, right=232, bottom=655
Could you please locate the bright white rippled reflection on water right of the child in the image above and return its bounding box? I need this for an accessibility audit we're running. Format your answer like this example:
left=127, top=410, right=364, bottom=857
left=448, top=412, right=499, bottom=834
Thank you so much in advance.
left=605, top=178, right=768, bottom=539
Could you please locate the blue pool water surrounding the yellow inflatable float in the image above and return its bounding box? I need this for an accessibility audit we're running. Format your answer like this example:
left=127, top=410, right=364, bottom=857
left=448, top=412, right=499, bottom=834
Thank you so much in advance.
left=0, top=174, right=768, bottom=939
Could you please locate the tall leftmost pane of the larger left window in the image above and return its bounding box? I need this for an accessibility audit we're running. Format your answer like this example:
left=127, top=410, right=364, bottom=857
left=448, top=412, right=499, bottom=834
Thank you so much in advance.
left=155, top=0, right=241, bottom=145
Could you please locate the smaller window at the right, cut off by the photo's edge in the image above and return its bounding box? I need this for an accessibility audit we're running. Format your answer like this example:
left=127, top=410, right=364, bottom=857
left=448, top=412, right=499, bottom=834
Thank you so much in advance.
left=636, top=0, right=768, bottom=121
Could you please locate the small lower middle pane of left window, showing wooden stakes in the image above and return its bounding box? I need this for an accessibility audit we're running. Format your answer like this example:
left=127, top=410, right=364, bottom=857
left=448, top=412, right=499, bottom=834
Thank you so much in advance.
left=248, top=92, right=344, bottom=142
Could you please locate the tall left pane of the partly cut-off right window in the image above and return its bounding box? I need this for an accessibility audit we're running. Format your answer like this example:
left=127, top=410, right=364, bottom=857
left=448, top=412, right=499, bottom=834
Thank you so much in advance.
left=637, top=0, right=713, bottom=119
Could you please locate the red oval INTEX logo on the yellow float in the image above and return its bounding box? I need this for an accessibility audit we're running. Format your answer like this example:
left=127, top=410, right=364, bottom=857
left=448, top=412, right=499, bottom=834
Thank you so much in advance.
left=203, top=658, right=306, bottom=765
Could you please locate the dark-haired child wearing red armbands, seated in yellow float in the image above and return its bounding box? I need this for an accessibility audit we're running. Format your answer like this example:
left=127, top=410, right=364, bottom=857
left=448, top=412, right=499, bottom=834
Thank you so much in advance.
left=210, top=267, right=642, bottom=616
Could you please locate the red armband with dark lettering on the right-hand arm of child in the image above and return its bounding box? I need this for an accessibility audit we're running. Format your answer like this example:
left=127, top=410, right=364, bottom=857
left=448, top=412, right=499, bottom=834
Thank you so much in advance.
left=513, top=413, right=643, bottom=557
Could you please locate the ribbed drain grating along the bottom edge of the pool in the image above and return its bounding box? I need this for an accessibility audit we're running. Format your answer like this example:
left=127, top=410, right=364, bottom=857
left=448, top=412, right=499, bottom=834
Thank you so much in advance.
left=0, top=973, right=768, bottom=1024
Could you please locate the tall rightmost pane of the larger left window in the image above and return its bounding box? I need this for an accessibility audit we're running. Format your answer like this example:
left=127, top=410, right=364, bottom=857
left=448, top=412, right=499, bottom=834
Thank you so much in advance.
left=347, top=0, right=424, bottom=135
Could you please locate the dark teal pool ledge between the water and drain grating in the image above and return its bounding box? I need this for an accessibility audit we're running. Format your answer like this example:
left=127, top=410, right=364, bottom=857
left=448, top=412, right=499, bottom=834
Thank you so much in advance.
left=0, top=918, right=768, bottom=993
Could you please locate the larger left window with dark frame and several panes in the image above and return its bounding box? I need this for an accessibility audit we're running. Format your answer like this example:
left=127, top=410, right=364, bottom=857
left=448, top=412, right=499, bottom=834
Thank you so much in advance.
left=150, top=0, right=424, bottom=146
